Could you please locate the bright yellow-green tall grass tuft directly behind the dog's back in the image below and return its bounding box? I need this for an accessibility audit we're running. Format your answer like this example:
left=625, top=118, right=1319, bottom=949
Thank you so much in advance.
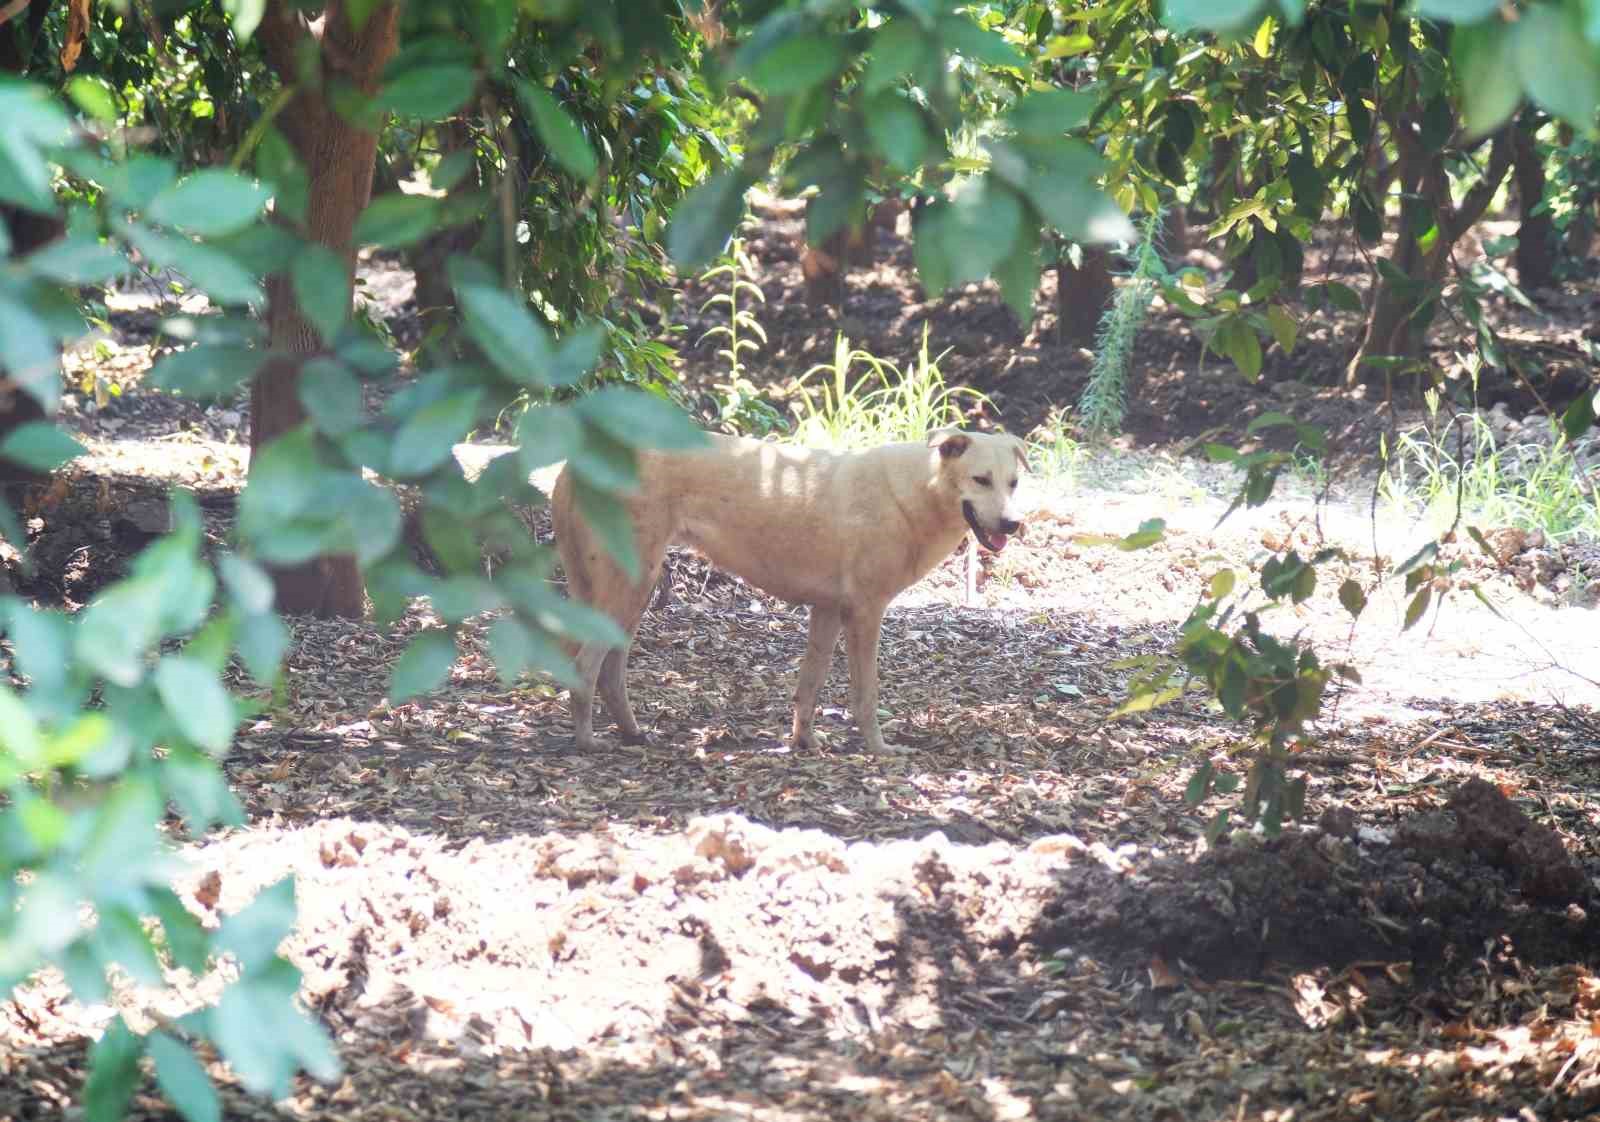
left=790, top=325, right=989, bottom=451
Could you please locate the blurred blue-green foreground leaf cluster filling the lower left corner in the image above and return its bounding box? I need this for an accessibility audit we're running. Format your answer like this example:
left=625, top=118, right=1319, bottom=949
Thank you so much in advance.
left=0, top=499, right=336, bottom=1122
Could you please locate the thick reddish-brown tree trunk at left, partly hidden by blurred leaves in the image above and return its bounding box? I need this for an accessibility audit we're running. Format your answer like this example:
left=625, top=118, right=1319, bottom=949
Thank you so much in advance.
left=250, top=0, right=398, bottom=618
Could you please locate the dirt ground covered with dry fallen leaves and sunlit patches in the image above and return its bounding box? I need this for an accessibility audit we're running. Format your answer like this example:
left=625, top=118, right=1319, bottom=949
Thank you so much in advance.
left=0, top=218, right=1600, bottom=1122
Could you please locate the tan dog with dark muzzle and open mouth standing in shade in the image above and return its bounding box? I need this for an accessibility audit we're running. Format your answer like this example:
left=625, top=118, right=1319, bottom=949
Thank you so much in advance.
left=550, top=429, right=1027, bottom=752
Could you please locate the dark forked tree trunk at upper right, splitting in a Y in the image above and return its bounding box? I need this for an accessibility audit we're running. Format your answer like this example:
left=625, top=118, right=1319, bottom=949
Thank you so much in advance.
left=1344, top=117, right=1515, bottom=389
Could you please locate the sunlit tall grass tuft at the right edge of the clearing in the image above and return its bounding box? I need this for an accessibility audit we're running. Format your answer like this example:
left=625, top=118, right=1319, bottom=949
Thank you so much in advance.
left=1379, top=415, right=1600, bottom=541
